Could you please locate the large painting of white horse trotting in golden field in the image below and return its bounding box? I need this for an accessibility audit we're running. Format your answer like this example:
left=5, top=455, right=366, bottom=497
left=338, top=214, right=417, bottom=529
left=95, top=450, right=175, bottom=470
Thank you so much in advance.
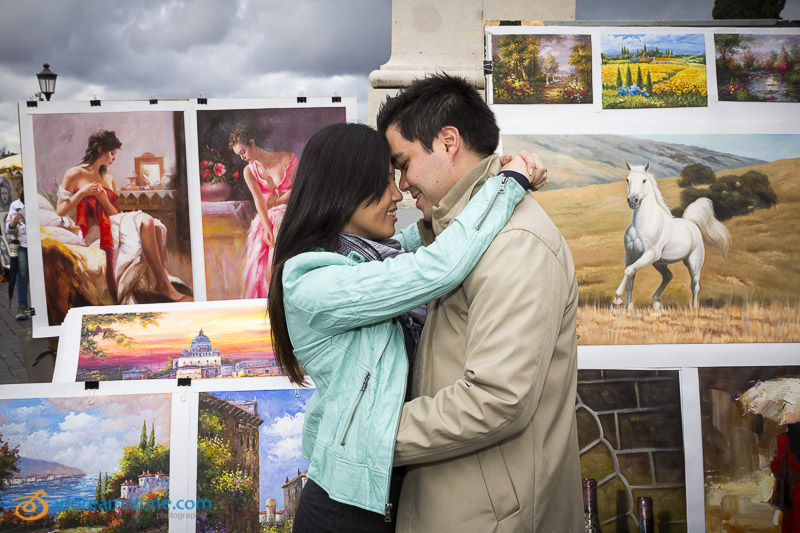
left=503, top=133, right=800, bottom=345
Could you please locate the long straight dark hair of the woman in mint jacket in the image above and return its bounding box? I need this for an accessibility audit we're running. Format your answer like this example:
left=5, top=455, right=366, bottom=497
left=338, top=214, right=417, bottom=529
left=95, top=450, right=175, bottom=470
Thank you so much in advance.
left=267, top=124, right=389, bottom=385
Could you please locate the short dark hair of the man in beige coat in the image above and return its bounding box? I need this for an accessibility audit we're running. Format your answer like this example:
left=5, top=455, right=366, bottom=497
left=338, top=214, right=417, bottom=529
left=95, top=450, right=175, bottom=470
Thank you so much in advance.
left=378, top=73, right=500, bottom=157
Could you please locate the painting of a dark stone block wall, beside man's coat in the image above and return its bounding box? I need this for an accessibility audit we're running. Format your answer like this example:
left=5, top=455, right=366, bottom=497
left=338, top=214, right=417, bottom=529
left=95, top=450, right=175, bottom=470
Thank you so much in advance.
left=575, top=370, right=687, bottom=532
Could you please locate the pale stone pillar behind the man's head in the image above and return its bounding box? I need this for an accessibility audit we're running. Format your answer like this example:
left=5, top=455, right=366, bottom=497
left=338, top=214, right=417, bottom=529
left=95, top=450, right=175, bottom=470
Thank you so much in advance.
left=369, top=0, right=575, bottom=125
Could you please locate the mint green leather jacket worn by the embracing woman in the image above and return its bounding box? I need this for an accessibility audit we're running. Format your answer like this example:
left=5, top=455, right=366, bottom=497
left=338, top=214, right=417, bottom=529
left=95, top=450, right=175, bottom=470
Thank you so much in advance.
left=283, top=175, right=525, bottom=513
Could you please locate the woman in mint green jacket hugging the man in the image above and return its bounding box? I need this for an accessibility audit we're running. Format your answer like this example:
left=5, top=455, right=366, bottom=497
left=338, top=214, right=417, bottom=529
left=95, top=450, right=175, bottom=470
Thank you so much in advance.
left=268, top=124, right=527, bottom=531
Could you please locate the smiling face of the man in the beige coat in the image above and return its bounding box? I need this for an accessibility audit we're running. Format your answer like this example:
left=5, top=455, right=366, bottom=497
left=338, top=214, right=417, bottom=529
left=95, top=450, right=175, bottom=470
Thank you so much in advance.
left=386, top=125, right=458, bottom=222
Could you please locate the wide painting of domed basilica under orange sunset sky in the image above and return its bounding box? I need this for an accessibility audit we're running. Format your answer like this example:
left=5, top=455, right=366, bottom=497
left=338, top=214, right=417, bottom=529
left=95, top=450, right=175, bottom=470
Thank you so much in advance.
left=74, top=300, right=280, bottom=381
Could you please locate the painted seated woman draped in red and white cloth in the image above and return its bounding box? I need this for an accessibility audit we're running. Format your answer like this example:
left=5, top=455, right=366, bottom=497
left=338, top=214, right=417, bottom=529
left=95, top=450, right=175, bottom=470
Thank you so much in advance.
left=56, top=130, right=187, bottom=303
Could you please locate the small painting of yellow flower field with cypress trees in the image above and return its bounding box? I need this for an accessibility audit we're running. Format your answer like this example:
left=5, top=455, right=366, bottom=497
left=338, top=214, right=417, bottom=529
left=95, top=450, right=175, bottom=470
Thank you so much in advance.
left=601, top=33, right=708, bottom=109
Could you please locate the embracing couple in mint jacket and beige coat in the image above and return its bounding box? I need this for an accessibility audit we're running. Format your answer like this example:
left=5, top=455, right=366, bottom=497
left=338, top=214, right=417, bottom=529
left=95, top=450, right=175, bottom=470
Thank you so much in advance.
left=269, top=75, right=583, bottom=532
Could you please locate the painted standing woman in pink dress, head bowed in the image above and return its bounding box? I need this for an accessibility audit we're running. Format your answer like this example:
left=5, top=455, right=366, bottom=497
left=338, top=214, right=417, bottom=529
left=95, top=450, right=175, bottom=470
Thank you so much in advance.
left=228, top=126, right=297, bottom=298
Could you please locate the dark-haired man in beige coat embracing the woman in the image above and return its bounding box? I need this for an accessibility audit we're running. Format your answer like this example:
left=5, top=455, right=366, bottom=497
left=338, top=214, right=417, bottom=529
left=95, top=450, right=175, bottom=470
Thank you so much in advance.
left=378, top=74, right=583, bottom=533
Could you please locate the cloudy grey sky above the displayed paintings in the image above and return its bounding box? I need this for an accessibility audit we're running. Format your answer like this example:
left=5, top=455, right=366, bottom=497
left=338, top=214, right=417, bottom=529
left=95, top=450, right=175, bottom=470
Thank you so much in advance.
left=0, top=0, right=800, bottom=152
